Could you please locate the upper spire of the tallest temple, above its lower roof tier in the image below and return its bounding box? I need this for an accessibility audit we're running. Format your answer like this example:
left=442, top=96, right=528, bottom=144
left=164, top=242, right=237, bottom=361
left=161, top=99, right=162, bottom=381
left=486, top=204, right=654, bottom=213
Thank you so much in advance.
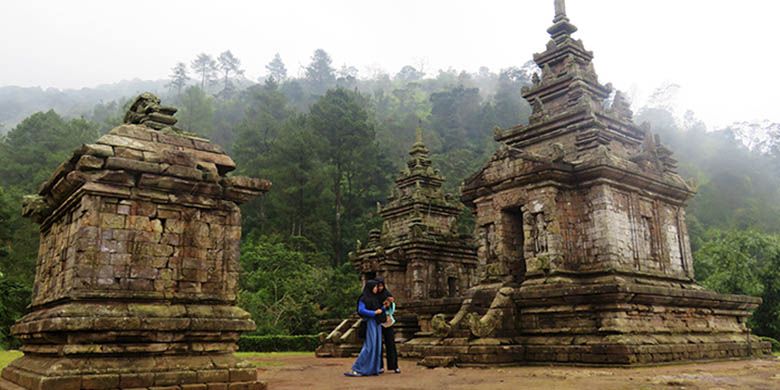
left=496, top=0, right=656, bottom=161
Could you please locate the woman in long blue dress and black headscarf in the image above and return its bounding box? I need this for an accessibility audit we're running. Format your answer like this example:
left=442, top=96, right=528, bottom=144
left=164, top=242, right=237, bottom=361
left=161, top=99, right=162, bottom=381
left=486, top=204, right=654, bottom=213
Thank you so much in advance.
left=344, top=280, right=384, bottom=376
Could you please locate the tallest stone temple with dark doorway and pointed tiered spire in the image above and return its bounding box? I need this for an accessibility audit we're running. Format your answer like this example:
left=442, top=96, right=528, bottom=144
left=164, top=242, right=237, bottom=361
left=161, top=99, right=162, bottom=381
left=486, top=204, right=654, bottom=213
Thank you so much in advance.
left=401, top=0, right=768, bottom=366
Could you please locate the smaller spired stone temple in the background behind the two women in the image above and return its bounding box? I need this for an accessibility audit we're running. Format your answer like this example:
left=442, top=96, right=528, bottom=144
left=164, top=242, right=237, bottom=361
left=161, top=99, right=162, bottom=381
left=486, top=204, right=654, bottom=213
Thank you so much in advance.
left=317, top=128, right=477, bottom=357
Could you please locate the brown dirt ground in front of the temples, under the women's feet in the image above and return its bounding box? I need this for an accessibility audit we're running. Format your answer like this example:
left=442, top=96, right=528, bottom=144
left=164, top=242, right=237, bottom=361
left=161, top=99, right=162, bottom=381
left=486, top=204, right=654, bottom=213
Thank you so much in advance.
left=250, top=355, right=780, bottom=390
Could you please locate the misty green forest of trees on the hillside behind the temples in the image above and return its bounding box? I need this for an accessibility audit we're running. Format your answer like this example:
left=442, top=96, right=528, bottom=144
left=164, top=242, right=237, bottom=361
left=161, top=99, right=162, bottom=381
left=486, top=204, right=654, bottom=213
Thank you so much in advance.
left=0, top=50, right=780, bottom=344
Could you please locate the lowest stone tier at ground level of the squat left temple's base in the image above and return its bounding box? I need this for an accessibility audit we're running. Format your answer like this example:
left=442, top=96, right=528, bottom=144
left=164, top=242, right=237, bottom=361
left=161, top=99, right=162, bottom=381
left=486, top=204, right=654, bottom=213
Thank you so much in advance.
left=0, top=354, right=266, bottom=390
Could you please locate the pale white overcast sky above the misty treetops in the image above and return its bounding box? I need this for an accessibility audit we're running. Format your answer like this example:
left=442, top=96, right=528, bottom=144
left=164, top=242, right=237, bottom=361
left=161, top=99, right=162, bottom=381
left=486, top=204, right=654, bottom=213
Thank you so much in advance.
left=0, top=0, right=780, bottom=126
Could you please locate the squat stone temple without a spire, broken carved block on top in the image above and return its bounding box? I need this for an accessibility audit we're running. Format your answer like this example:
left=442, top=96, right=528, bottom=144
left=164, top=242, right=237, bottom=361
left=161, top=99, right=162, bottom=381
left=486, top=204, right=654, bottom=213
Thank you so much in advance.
left=0, top=94, right=270, bottom=390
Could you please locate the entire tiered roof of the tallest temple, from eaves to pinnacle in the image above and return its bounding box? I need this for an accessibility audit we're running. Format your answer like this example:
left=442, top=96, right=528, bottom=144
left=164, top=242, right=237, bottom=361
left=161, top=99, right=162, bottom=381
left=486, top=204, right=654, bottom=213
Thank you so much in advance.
left=463, top=0, right=693, bottom=204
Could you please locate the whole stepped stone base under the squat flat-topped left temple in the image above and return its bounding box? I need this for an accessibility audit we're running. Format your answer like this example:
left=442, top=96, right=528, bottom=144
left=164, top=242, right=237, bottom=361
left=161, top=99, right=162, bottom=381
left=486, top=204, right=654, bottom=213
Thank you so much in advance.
left=0, top=301, right=265, bottom=390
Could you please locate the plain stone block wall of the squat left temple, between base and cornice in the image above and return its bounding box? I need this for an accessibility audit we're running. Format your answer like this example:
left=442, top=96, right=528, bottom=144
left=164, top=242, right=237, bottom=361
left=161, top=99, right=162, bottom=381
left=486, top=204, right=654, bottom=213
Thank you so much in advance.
left=32, top=195, right=241, bottom=306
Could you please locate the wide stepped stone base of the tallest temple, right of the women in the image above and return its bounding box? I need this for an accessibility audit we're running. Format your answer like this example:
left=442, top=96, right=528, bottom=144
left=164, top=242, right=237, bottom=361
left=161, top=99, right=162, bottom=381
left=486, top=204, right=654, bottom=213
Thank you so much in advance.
left=399, top=275, right=771, bottom=366
